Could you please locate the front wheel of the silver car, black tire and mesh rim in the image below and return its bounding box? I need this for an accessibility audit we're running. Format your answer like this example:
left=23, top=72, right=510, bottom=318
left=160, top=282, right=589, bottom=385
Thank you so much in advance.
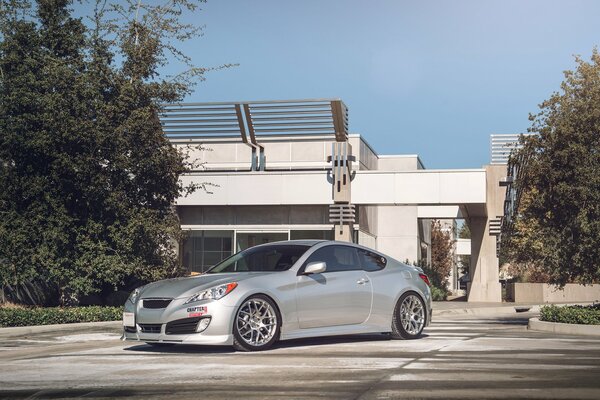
left=233, top=295, right=281, bottom=351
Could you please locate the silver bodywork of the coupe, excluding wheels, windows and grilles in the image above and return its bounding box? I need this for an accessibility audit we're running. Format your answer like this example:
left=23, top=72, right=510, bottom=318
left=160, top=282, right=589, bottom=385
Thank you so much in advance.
left=123, top=241, right=431, bottom=345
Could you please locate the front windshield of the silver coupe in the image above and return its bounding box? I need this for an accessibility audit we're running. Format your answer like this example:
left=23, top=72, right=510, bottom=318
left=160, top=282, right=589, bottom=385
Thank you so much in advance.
left=206, top=244, right=310, bottom=274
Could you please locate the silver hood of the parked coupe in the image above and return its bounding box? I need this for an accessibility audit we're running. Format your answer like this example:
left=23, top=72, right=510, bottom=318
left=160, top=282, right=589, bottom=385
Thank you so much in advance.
left=140, top=272, right=273, bottom=299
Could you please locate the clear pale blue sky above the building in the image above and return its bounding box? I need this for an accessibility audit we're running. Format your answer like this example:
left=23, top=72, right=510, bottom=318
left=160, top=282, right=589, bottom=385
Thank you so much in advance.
left=101, top=0, right=600, bottom=168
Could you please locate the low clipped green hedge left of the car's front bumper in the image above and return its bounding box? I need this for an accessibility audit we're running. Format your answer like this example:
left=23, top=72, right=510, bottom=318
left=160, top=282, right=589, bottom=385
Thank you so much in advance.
left=0, top=306, right=123, bottom=327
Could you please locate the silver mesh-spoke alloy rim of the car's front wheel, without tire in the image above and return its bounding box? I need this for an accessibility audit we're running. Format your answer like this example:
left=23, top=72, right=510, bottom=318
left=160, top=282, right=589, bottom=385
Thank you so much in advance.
left=235, top=298, right=277, bottom=346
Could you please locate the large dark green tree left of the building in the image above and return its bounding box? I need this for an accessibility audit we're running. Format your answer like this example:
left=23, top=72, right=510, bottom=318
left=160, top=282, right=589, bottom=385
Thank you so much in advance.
left=0, top=0, right=220, bottom=304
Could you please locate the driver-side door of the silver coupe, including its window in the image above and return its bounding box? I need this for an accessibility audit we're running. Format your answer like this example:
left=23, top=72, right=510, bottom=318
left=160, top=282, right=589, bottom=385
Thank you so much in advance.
left=296, top=245, right=373, bottom=328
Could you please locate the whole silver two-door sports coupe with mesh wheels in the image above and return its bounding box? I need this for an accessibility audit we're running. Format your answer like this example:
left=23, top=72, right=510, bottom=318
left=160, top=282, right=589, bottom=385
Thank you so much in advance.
left=123, top=240, right=431, bottom=351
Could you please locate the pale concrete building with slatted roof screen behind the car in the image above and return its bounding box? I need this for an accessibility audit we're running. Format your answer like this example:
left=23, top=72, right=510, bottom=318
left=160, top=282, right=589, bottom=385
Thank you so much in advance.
left=161, top=99, right=506, bottom=301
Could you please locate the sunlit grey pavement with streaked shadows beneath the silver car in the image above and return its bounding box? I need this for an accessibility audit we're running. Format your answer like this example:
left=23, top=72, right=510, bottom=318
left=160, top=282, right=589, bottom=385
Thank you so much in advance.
left=0, top=313, right=600, bottom=399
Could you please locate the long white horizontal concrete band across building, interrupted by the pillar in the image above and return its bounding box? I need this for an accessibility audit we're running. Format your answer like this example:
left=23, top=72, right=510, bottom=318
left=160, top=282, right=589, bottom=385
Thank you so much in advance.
left=177, top=170, right=486, bottom=205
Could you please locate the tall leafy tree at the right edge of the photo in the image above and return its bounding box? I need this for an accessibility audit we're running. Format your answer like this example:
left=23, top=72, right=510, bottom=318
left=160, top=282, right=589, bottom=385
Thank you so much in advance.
left=505, top=49, right=600, bottom=285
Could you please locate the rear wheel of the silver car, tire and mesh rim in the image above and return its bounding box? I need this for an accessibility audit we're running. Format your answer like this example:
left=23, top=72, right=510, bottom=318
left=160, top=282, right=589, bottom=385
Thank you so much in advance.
left=392, top=292, right=427, bottom=340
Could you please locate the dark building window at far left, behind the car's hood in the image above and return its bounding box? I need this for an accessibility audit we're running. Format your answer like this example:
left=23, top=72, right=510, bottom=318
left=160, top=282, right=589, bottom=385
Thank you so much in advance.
left=182, top=231, right=233, bottom=272
